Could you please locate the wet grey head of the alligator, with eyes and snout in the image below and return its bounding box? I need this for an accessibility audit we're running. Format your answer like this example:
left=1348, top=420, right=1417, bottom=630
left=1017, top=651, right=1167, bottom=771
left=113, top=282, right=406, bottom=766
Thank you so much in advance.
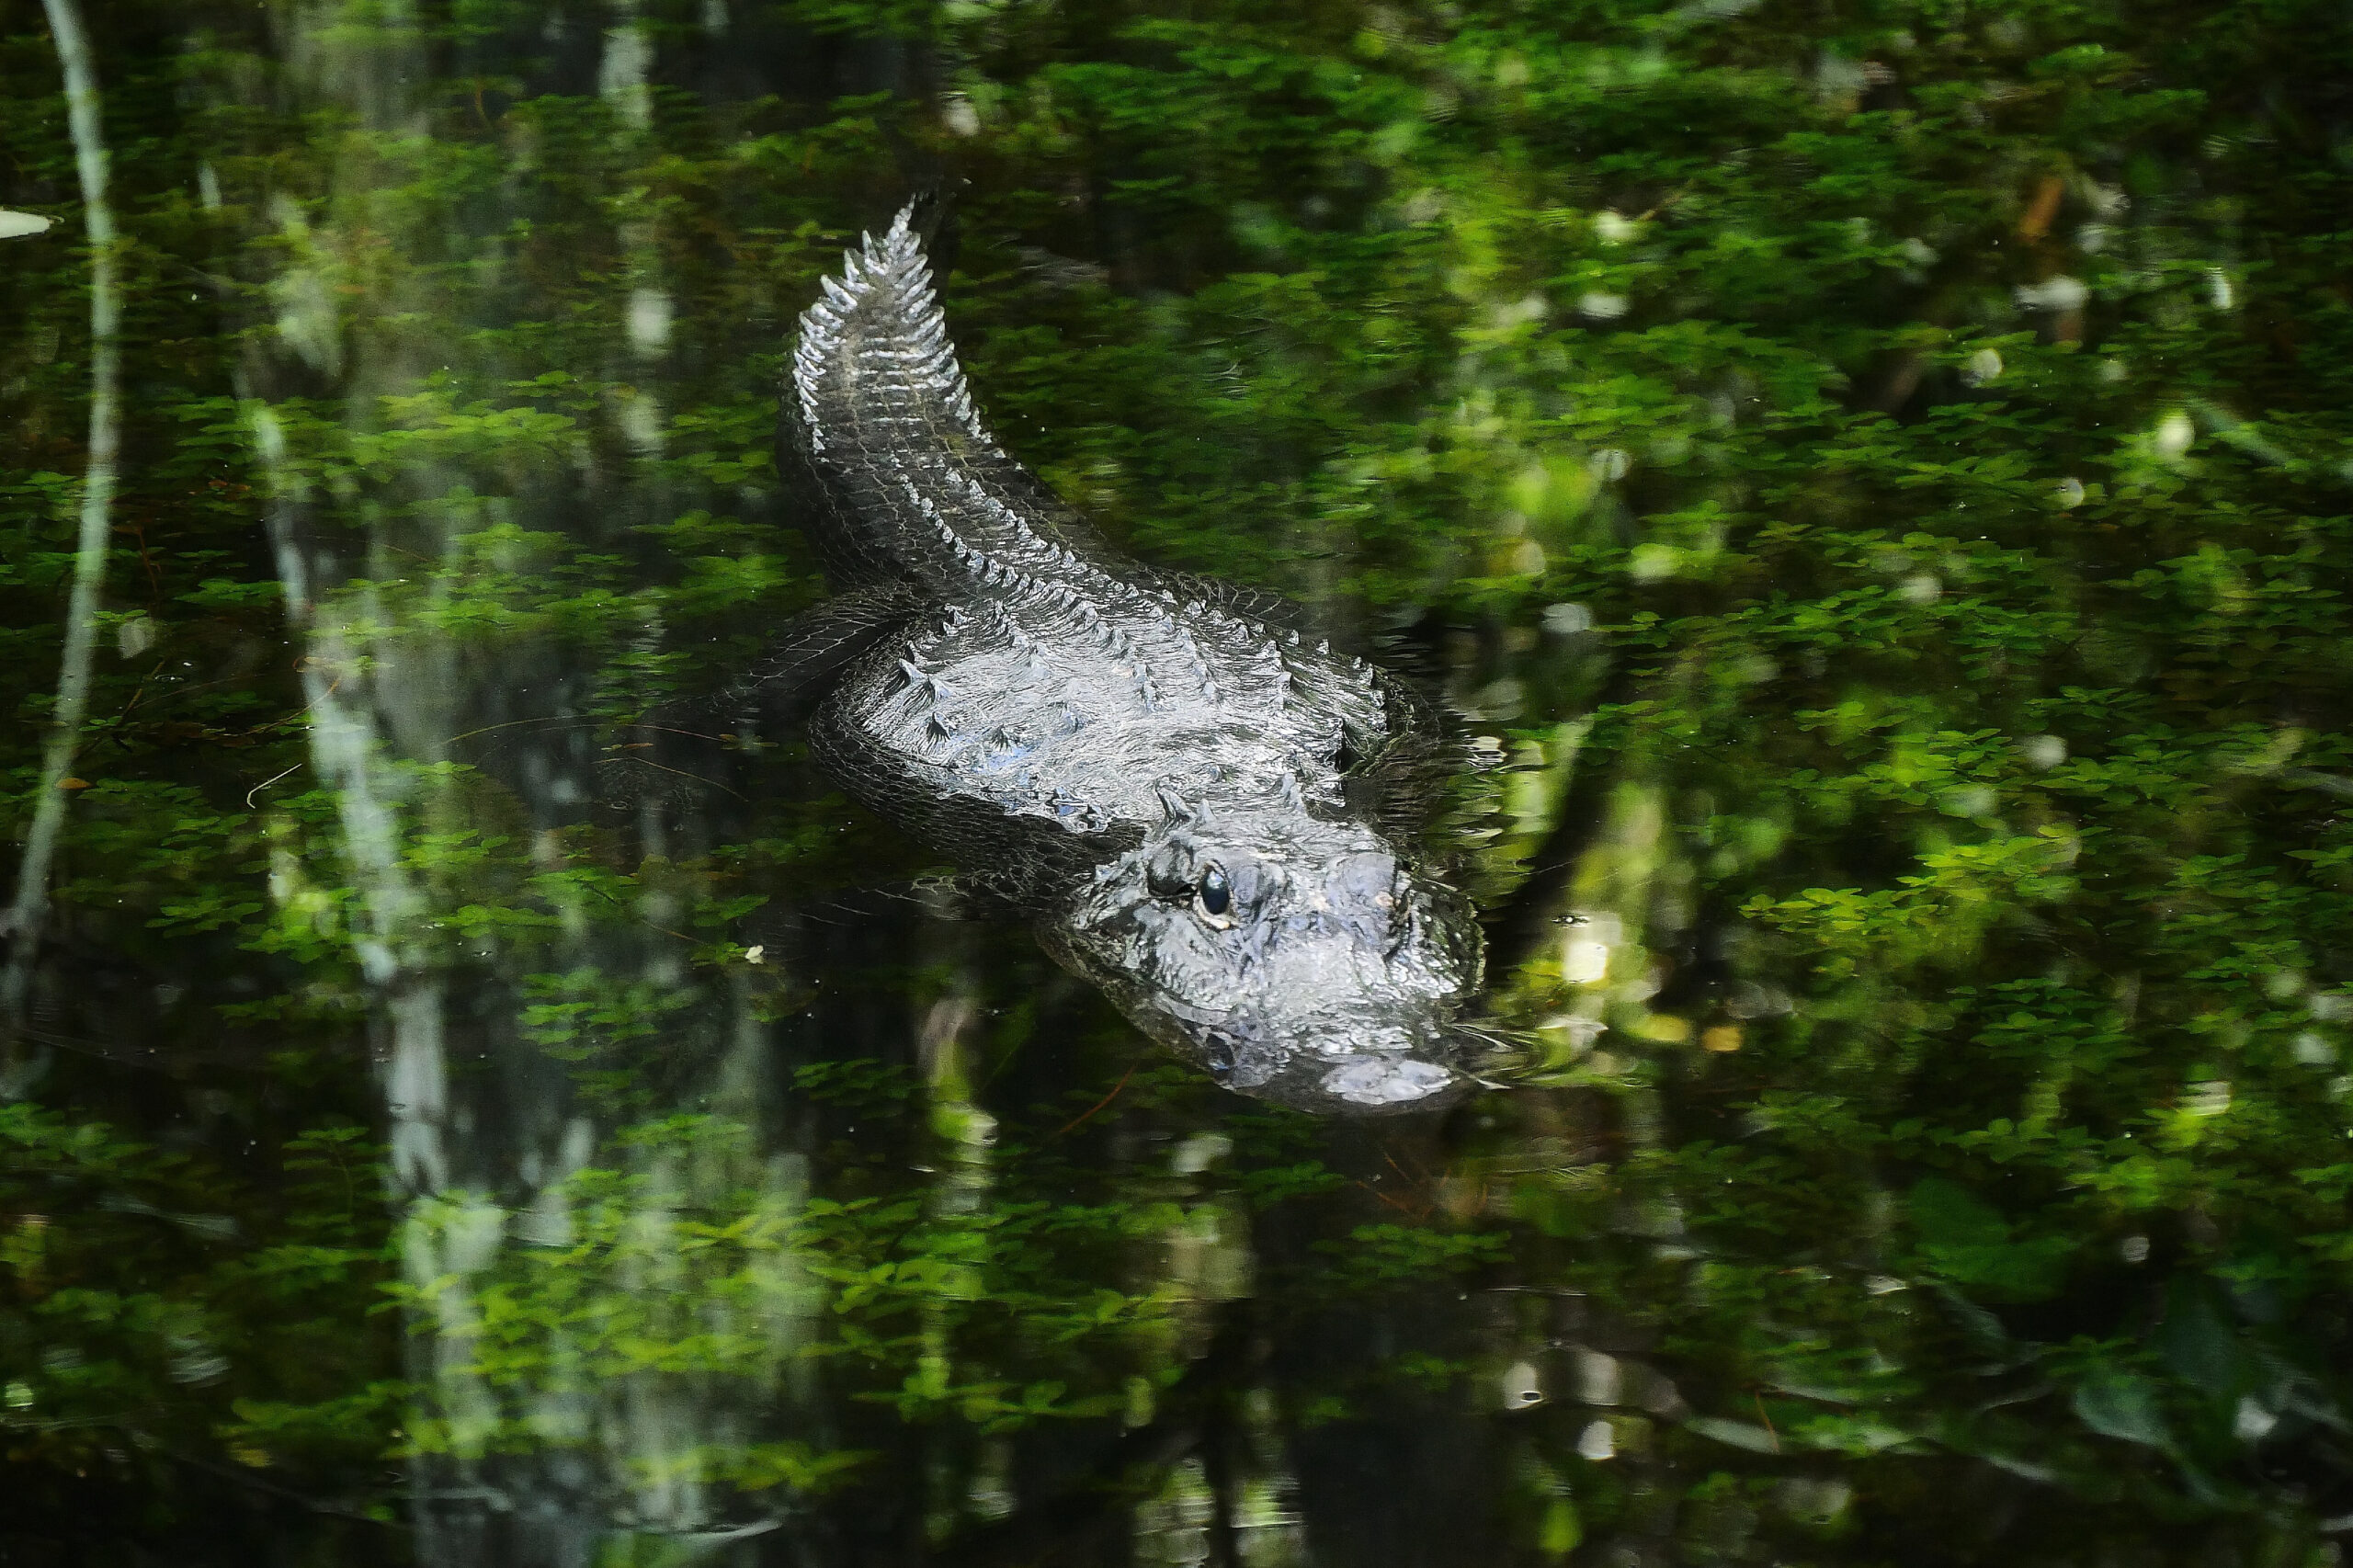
left=1040, top=793, right=1480, bottom=1114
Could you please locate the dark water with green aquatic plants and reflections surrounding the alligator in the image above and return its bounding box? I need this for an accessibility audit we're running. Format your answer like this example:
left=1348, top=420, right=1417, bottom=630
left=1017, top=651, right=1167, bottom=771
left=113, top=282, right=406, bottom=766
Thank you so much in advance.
left=0, top=0, right=2353, bottom=1568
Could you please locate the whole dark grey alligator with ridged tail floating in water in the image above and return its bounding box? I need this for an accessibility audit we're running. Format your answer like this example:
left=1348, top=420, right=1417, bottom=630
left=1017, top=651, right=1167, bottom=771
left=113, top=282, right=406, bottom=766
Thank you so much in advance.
left=748, top=205, right=1480, bottom=1114
